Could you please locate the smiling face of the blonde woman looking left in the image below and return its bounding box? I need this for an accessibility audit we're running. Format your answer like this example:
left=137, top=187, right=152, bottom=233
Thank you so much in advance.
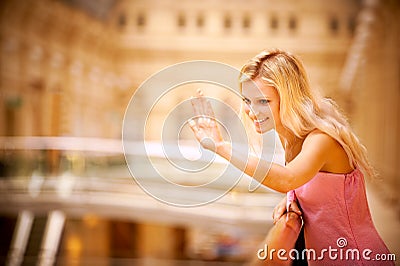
left=242, top=78, right=282, bottom=134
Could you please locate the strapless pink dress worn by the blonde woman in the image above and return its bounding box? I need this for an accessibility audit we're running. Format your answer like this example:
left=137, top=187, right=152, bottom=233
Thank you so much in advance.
left=287, top=169, right=394, bottom=265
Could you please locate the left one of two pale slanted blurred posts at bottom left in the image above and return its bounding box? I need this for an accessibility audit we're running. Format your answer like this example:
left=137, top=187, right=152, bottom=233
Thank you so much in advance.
left=6, top=211, right=34, bottom=266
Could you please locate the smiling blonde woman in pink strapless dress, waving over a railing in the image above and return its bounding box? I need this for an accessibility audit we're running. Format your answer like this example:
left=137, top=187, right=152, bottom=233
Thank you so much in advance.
left=189, top=50, right=392, bottom=265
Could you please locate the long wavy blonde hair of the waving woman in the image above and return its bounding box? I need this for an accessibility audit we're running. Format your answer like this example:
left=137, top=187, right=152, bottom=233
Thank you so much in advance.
left=239, top=50, right=377, bottom=177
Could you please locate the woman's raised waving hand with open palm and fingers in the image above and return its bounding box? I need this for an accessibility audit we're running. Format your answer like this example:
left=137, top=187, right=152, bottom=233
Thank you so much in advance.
left=188, top=90, right=224, bottom=152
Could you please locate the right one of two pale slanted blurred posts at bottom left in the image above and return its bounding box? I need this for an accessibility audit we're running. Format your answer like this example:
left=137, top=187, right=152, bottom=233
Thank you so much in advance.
left=38, top=211, right=65, bottom=266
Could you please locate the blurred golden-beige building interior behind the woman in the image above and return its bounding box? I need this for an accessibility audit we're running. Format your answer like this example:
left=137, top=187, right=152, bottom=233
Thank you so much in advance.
left=0, top=0, right=400, bottom=265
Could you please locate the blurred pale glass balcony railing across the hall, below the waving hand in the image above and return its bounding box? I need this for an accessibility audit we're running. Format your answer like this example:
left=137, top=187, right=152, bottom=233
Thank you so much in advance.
left=0, top=137, right=282, bottom=215
